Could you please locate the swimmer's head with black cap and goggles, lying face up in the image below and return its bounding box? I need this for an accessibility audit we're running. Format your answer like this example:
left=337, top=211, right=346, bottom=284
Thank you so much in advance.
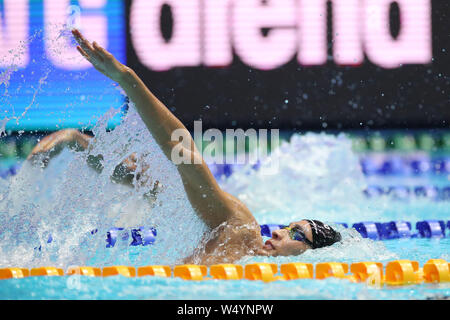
left=264, top=220, right=341, bottom=256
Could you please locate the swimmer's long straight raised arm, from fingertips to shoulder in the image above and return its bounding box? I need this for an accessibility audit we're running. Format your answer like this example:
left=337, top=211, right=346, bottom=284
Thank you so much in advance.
left=73, top=30, right=253, bottom=228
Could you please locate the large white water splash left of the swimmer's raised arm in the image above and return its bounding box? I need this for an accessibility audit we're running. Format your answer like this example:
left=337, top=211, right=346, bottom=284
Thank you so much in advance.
left=0, top=104, right=206, bottom=267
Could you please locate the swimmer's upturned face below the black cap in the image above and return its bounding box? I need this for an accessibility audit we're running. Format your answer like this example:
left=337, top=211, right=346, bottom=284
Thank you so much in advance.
left=263, top=220, right=312, bottom=256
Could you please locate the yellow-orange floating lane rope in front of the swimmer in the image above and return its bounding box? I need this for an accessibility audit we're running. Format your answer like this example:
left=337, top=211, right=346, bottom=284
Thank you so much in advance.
left=0, top=259, right=450, bottom=288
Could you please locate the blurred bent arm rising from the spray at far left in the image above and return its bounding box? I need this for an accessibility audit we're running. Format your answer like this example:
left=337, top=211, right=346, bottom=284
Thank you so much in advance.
left=27, top=129, right=90, bottom=160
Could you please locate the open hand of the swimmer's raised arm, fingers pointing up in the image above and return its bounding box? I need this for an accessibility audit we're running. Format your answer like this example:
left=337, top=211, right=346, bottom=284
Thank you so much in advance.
left=72, top=29, right=127, bottom=82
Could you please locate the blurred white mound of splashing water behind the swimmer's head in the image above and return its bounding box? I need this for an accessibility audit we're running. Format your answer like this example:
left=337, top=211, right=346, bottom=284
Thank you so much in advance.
left=223, top=133, right=367, bottom=223
